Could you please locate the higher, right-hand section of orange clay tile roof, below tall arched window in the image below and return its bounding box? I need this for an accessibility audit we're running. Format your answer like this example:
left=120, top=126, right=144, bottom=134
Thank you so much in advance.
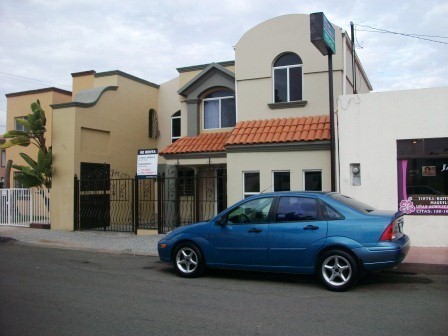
left=226, top=115, right=330, bottom=145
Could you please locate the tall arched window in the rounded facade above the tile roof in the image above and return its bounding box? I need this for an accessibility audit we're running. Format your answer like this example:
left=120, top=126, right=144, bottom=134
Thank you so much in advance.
left=273, top=53, right=302, bottom=103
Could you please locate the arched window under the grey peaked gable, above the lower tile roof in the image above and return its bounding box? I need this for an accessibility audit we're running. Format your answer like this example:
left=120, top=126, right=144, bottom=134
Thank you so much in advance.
left=202, top=90, right=236, bottom=129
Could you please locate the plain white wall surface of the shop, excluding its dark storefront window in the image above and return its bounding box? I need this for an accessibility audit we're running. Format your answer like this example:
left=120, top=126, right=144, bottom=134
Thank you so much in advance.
left=337, top=87, right=448, bottom=246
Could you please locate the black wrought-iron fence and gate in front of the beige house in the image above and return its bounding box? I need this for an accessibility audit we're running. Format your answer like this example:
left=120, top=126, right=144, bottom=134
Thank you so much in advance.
left=74, top=174, right=227, bottom=233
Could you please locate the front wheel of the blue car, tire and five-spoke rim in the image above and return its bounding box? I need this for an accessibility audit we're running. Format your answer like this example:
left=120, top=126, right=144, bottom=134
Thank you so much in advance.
left=173, top=243, right=205, bottom=278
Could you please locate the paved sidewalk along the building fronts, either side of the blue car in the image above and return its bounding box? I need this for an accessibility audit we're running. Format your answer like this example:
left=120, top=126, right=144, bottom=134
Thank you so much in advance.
left=0, top=226, right=448, bottom=265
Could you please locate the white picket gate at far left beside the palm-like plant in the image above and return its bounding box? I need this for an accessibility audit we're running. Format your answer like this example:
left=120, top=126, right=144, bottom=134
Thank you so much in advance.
left=0, top=188, right=50, bottom=227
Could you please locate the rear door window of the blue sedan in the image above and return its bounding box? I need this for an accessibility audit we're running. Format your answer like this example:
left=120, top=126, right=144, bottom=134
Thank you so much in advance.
left=275, top=196, right=319, bottom=222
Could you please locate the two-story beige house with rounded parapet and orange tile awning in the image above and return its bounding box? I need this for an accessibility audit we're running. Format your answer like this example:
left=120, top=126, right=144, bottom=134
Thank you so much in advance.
left=3, top=14, right=372, bottom=230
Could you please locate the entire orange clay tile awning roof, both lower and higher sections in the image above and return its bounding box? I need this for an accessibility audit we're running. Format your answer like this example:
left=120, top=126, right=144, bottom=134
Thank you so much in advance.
left=160, top=115, right=330, bottom=155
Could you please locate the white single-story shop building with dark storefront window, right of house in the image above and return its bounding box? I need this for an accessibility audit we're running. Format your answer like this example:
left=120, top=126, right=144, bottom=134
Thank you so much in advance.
left=337, top=87, right=448, bottom=247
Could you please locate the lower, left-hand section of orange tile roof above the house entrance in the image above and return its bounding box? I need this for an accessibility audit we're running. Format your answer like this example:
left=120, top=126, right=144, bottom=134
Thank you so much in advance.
left=160, top=132, right=230, bottom=155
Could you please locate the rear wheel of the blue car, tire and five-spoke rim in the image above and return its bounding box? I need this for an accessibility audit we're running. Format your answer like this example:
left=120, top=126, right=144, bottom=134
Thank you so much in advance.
left=317, top=250, right=359, bottom=292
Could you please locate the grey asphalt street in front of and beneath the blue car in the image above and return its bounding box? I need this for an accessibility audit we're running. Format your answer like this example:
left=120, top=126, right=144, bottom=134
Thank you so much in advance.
left=0, top=240, right=448, bottom=336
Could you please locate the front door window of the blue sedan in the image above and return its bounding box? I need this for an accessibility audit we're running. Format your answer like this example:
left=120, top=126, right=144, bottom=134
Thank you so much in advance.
left=227, top=197, right=274, bottom=224
